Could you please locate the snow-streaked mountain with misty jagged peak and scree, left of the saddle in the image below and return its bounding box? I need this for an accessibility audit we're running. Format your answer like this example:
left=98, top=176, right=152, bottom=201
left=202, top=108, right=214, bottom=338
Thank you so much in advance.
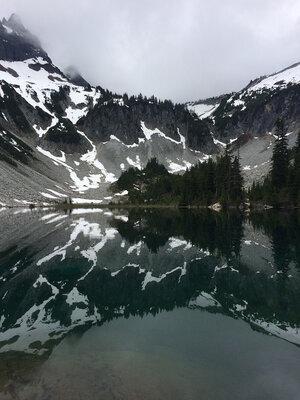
left=0, top=15, right=215, bottom=204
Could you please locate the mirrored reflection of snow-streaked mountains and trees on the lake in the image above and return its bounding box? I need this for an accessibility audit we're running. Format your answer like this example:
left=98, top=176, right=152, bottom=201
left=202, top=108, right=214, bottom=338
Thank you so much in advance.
left=0, top=209, right=300, bottom=399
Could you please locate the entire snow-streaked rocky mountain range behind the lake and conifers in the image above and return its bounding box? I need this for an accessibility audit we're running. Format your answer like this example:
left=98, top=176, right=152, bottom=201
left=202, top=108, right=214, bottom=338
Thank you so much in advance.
left=0, top=15, right=300, bottom=205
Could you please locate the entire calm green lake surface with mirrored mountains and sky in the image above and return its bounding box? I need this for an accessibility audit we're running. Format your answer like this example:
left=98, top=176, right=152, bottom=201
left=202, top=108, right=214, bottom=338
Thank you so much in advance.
left=0, top=209, right=300, bottom=400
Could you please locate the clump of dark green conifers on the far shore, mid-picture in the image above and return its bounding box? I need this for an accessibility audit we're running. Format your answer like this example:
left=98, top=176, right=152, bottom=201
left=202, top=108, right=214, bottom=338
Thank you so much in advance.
left=112, top=153, right=244, bottom=207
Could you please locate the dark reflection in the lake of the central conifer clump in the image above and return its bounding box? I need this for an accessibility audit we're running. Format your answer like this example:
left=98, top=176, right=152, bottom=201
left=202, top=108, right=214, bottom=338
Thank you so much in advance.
left=112, top=208, right=243, bottom=260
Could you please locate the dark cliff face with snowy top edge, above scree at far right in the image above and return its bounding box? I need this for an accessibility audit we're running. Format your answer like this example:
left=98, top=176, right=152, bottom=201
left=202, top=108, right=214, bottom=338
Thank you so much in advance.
left=213, top=64, right=300, bottom=142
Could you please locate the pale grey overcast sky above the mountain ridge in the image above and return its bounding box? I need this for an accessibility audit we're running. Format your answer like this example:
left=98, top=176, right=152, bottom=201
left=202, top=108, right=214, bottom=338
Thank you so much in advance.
left=0, top=0, right=300, bottom=101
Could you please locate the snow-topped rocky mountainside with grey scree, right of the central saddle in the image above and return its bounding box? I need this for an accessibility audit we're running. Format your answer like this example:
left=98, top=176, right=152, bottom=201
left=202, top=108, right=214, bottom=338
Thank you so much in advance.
left=187, top=63, right=300, bottom=184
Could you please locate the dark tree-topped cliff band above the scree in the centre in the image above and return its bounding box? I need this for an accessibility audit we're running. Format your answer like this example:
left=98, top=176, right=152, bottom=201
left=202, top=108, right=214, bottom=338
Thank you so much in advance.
left=77, top=91, right=213, bottom=153
